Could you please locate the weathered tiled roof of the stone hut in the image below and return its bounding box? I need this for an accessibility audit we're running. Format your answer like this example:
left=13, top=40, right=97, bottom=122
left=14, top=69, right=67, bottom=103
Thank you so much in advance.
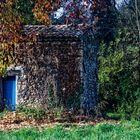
left=24, top=25, right=92, bottom=38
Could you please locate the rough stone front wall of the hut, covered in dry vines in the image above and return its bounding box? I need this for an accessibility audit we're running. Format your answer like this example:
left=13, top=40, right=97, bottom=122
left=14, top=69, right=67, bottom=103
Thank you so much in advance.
left=17, top=40, right=82, bottom=108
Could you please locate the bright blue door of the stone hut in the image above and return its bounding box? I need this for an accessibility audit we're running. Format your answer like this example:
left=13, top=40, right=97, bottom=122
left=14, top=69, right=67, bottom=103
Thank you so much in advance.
left=3, top=76, right=16, bottom=111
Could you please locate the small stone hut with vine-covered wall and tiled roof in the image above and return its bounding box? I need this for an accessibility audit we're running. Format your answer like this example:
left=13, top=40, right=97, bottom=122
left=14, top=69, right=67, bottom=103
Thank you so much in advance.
left=2, top=25, right=96, bottom=108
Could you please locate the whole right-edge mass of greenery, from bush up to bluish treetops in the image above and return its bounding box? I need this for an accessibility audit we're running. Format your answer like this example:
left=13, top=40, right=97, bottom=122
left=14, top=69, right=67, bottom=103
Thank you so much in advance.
left=99, top=1, right=140, bottom=119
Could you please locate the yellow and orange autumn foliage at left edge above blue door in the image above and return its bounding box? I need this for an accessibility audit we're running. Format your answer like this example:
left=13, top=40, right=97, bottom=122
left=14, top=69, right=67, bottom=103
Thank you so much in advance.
left=0, top=0, right=22, bottom=108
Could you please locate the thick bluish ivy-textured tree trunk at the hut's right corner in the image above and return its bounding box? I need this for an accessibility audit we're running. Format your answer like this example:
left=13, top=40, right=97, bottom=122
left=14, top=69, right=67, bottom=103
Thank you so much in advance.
left=81, top=37, right=99, bottom=115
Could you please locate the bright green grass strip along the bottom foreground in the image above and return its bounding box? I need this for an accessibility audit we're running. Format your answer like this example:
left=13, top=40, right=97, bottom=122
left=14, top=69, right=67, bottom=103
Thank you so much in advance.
left=0, top=121, right=140, bottom=140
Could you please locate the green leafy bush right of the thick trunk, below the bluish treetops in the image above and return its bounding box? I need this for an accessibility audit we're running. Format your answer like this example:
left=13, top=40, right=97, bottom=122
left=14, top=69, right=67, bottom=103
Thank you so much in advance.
left=98, top=32, right=140, bottom=119
